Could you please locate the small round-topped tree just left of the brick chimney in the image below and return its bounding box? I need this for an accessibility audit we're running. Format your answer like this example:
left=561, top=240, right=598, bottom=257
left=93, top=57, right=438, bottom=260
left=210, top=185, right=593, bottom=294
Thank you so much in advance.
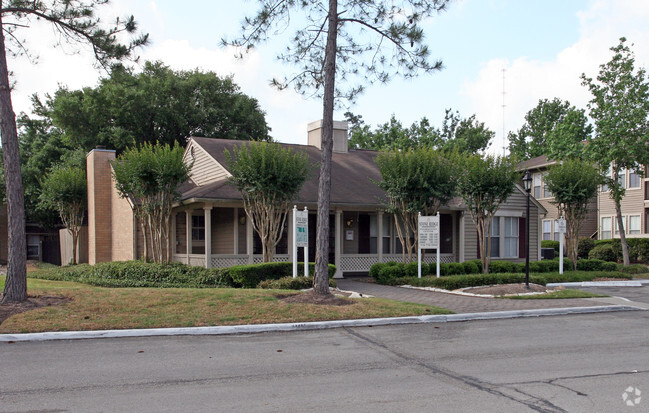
left=40, top=167, right=88, bottom=265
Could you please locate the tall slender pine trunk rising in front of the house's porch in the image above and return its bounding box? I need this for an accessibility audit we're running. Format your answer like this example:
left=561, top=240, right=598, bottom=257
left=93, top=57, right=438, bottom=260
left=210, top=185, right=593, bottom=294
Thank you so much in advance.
left=313, top=0, right=338, bottom=295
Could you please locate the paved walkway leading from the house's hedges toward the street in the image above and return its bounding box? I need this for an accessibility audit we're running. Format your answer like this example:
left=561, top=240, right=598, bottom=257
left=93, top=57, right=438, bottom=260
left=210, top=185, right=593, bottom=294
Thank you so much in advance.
left=336, top=278, right=629, bottom=314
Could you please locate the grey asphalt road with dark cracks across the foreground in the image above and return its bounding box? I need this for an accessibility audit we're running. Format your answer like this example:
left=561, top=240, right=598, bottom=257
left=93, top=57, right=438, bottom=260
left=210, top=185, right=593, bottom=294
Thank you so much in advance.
left=0, top=311, right=649, bottom=412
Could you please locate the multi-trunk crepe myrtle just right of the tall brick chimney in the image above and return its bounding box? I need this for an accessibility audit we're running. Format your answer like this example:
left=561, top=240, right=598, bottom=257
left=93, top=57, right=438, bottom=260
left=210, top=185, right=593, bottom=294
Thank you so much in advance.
left=112, top=142, right=187, bottom=262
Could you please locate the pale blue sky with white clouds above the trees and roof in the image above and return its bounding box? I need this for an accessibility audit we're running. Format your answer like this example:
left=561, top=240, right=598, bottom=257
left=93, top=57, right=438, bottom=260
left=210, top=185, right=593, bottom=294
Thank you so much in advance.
left=8, top=0, right=649, bottom=154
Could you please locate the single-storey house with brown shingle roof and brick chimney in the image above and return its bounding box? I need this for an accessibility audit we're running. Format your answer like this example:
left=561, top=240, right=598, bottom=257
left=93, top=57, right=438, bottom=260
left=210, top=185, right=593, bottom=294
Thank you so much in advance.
left=81, top=121, right=546, bottom=277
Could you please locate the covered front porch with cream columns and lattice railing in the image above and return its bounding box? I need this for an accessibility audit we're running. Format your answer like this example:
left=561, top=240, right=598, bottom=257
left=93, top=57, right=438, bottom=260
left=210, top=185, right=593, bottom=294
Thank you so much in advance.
left=171, top=203, right=463, bottom=278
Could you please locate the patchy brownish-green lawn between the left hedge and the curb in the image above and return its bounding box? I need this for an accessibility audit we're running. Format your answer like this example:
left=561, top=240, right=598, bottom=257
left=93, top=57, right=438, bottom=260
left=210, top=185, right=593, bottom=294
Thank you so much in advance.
left=0, top=277, right=451, bottom=334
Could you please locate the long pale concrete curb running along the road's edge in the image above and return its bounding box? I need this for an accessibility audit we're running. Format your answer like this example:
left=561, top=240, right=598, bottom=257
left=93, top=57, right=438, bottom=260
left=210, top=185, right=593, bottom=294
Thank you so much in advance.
left=0, top=305, right=644, bottom=343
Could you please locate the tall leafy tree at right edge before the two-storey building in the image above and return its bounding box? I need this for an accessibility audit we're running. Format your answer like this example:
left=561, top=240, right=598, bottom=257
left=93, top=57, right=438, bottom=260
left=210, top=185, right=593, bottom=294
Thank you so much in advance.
left=581, top=37, right=649, bottom=265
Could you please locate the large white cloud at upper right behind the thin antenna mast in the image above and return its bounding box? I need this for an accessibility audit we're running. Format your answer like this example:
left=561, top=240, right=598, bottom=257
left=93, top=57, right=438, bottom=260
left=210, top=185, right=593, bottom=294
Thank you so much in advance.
left=461, top=0, right=649, bottom=151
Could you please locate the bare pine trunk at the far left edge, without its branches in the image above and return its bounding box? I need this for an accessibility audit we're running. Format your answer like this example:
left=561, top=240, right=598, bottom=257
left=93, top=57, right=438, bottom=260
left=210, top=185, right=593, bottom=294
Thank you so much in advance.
left=0, top=15, right=27, bottom=304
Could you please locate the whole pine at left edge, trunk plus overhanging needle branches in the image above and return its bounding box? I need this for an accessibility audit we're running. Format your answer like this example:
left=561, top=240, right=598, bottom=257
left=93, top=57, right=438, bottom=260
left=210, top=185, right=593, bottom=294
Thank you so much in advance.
left=0, top=0, right=148, bottom=303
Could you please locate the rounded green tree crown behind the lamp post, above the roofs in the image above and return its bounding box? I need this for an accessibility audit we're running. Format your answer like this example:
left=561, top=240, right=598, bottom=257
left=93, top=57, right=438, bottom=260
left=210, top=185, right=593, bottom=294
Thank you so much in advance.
left=509, top=98, right=593, bottom=161
